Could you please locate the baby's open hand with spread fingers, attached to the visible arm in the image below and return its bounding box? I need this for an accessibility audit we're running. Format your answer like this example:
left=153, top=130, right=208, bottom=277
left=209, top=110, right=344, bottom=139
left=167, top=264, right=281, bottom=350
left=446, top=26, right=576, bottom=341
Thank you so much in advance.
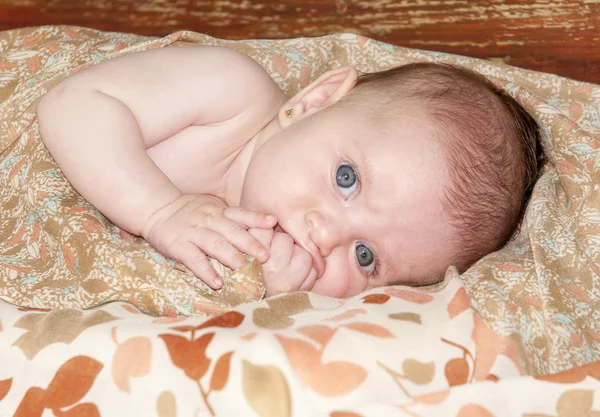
left=142, top=194, right=277, bottom=289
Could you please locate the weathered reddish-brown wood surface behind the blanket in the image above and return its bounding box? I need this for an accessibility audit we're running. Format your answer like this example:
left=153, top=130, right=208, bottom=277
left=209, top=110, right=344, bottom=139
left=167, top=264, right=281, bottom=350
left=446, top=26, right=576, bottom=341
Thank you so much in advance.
left=0, top=0, right=600, bottom=83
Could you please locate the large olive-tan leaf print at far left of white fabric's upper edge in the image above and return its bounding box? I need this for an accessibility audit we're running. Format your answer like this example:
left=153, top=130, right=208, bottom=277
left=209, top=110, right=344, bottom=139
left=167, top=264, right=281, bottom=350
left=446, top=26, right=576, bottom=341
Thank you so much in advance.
left=13, top=309, right=117, bottom=360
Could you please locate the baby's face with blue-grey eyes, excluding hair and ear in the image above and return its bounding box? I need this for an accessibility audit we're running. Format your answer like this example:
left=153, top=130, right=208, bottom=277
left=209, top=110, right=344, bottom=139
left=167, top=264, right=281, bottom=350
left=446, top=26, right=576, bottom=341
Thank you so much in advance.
left=240, top=107, right=452, bottom=297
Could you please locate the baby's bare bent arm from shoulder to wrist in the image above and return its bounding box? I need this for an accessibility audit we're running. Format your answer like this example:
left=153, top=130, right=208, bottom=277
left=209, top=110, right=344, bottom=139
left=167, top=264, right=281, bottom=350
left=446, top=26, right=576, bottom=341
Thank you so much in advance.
left=37, top=47, right=280, bottom=286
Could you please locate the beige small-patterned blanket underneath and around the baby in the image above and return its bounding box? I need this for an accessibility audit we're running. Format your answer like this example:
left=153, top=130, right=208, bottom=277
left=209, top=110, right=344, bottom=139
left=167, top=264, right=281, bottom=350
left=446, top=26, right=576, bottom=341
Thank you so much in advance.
left=0, top=27, right=600, bottom=374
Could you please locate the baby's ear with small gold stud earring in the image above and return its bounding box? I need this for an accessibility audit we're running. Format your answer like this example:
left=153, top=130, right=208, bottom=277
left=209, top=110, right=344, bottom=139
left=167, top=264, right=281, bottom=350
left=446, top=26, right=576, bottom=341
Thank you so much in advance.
left=278, top=68, right=358, bottom=128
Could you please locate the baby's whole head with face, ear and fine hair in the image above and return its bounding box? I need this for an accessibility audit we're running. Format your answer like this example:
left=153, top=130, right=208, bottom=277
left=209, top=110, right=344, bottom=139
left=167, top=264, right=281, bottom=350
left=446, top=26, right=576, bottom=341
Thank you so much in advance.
left=240, top=63, right=543, bottom=297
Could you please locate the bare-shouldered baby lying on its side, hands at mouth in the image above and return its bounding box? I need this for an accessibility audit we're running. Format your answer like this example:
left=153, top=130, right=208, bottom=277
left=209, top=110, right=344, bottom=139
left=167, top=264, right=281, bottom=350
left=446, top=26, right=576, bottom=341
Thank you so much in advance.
left=37, top=46, right=543, bottom=297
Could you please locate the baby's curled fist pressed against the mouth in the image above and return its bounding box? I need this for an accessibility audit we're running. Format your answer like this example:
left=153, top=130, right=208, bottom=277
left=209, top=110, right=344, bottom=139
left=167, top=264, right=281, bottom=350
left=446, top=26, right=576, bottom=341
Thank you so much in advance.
left=248, top=229, right=317, bottom=296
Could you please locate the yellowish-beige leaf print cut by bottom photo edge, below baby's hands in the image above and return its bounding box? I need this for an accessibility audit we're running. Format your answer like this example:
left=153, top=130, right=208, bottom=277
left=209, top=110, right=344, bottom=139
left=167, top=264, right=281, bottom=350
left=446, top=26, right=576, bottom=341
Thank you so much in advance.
left=241, top=360, right=292, bottom=417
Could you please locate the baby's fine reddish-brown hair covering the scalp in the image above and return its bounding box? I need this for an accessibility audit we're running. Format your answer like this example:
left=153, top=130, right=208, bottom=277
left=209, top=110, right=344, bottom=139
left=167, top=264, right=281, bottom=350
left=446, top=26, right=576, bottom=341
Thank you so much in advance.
left=342, top=62, right=546, bottom=272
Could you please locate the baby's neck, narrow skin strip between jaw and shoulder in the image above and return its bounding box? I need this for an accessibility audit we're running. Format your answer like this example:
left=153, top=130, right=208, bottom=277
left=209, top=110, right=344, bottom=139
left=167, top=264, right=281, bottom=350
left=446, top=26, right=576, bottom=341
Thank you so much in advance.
left=223, top=116, right=282, bottom=206
